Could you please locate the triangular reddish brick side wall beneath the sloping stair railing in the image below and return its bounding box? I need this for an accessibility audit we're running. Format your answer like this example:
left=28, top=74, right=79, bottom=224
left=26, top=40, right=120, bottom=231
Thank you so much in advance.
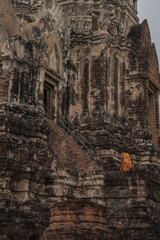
left=47, top=120, right=101, bottom=173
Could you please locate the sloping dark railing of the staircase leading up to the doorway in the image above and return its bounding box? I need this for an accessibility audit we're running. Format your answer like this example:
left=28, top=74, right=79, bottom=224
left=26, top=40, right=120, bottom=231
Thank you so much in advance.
left=41, top=105, right=97, bottom=158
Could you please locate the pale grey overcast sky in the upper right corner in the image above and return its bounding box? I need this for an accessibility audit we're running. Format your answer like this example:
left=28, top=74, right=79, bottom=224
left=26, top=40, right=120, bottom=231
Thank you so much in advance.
left=138, top=0, right=160, bottom=65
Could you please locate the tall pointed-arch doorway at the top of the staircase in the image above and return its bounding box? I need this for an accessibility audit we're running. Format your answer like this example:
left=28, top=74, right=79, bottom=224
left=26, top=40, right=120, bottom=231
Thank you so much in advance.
left=43, top=32, right=64, bottom=116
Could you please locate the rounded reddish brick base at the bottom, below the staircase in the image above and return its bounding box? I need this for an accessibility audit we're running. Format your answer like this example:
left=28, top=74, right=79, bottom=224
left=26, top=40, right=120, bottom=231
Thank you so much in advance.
left=42, top=200, right=113, bottom=240
